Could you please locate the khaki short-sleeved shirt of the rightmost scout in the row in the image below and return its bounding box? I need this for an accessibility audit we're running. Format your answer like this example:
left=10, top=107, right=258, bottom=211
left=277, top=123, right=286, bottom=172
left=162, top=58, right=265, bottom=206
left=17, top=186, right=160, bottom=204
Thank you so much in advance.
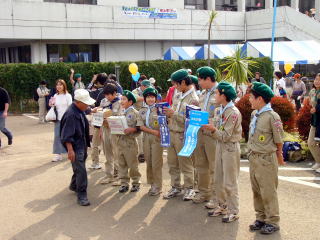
left=248, top=111, right=284, bottom=153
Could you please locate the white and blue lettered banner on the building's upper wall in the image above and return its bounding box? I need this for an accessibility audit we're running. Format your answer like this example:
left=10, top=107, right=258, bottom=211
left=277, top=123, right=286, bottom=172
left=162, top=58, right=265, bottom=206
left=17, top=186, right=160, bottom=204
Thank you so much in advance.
left=122, top=6, right=178, bottom=19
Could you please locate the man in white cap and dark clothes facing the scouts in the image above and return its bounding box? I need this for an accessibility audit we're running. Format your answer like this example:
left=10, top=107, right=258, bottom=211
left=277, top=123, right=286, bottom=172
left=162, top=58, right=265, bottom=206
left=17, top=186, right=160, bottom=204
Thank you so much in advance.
left=60, top=89, right=95, bottom=206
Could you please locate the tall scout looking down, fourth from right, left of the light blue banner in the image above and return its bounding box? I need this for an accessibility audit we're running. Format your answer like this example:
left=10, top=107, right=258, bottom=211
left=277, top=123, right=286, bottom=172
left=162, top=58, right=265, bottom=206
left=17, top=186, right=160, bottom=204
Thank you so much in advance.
left=163, top=69, right=199, bottom=201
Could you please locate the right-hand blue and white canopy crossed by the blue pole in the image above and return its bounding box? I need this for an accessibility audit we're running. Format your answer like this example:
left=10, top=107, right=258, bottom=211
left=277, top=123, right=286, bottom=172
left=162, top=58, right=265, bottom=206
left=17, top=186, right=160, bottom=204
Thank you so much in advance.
left=244, top=40, right=320, bottom=64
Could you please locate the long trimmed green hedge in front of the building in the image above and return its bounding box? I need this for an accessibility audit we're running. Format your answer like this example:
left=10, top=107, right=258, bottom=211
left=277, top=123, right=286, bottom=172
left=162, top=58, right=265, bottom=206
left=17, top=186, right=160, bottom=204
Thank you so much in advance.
left=0, top=58, right=273, bottom=111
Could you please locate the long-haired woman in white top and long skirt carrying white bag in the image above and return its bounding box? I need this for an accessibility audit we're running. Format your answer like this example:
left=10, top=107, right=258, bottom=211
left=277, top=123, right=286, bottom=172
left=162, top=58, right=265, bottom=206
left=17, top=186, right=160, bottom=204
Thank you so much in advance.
left=50, top=79, right=72, bottom=162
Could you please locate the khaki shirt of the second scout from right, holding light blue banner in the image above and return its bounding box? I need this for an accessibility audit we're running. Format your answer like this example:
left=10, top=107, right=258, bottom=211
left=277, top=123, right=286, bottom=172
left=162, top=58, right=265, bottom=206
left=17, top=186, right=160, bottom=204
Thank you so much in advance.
left=212, top=106, right=242, bottom=143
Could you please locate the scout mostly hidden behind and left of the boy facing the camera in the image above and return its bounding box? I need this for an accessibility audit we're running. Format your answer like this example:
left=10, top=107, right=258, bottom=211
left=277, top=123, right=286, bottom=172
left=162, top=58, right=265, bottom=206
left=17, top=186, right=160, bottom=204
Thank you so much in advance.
left=132, top=80, right=151, bottom=162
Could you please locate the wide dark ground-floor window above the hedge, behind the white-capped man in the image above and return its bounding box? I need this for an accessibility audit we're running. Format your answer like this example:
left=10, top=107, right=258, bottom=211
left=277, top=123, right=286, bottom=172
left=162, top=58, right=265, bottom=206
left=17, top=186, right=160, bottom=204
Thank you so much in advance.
left=47, top=44, right=99, bottom=63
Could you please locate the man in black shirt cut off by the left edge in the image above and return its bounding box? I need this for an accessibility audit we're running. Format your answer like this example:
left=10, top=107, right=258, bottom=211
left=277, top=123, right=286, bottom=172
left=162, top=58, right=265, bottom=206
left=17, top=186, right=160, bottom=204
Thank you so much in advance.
left=0, top=87, right=13, bottom=147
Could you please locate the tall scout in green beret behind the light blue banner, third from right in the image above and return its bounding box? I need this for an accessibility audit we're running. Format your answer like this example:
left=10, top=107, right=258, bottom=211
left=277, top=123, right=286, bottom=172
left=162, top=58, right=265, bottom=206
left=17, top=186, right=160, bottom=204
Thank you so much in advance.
left=192, top=67, right=218, bottom=204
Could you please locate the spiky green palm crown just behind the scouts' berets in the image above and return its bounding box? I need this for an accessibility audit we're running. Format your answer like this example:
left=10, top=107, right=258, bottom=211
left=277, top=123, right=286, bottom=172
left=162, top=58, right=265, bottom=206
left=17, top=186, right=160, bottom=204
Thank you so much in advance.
left=219, top=46, right=259, bottom=89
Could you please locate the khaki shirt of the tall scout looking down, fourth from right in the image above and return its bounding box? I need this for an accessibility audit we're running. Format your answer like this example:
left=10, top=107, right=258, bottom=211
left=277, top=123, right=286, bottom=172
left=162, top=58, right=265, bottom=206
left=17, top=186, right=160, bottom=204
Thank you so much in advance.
left=169, top=88, right=199, bottom=133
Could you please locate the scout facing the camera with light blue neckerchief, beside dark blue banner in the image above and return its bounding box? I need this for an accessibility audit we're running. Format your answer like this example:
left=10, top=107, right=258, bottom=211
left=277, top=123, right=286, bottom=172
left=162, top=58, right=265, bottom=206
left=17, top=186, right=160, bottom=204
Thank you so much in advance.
left=137, top=87, right=163, bottom=196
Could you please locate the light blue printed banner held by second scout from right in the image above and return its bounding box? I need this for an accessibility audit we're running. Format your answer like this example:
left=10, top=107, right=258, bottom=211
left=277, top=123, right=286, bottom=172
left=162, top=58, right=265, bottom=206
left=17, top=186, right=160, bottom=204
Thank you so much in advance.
left=178, top=111, right=209, bottom=157
